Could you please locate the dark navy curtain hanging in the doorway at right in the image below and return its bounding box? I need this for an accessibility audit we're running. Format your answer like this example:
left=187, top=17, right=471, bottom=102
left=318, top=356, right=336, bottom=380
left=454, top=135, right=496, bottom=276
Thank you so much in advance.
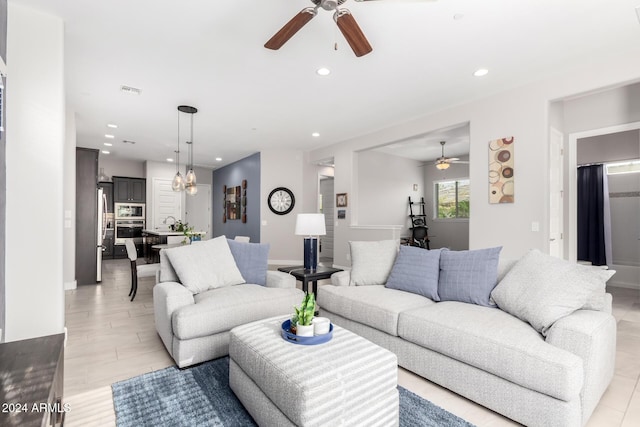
left=578, top=165, right=607, bottom=265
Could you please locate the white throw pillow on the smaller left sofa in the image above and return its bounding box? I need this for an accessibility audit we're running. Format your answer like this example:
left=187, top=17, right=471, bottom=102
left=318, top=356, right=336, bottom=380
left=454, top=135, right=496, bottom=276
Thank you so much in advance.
left=165, top=236, right=245, bottom=294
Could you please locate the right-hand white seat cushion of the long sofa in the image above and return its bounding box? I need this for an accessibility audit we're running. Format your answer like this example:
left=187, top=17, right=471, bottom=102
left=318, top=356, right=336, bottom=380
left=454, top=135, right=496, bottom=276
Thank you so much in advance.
left=398, top=301, right=583, bottom=401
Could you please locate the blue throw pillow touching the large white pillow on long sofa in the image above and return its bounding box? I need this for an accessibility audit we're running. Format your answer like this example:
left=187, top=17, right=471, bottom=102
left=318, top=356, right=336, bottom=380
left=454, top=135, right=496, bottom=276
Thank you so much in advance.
left=438, top=246, right=502, bottom=307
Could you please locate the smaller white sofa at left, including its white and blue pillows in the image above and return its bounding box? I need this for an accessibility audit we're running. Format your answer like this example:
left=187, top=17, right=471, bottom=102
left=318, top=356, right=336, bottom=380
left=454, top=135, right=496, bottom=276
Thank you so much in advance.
left=153, top=236, right=304, bottom=368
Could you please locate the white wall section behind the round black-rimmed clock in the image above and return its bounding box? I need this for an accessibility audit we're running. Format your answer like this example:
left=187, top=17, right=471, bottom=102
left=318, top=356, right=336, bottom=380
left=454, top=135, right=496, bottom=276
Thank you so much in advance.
left=260, top=150, right=304, bottom=264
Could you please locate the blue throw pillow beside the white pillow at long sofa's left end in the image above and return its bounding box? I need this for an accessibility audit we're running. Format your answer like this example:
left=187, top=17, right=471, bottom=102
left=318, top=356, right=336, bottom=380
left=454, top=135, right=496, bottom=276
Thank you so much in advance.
left=385, top=246, right=440, bottom=301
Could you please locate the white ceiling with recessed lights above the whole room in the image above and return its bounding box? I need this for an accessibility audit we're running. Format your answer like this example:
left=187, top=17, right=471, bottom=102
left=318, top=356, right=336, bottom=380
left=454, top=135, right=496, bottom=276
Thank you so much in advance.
left=13, top=0, right=640, bottom=167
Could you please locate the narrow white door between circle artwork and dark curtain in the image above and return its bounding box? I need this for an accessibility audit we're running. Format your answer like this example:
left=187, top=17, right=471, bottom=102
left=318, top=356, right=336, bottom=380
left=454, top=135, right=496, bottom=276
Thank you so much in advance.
left=549, top=128, right=564, bottom=258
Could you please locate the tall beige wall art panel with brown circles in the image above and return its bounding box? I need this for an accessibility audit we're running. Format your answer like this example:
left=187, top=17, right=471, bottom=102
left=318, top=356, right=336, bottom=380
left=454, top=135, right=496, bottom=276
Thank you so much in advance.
left=489, top=137, right=515, bottom=203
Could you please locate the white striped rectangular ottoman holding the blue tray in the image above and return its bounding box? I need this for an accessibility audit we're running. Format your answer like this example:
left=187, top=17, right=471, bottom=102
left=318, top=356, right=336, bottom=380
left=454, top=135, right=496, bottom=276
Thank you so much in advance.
left=229, top=317, right=399, bottom=427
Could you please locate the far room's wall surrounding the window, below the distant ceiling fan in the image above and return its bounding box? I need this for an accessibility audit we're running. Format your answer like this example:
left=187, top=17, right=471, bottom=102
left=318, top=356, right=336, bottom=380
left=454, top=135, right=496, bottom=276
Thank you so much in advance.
left=423, top=157, right=473, bottom=251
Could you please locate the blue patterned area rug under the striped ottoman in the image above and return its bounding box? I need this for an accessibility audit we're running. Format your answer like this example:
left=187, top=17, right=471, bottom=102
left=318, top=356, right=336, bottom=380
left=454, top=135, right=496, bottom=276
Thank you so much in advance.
left=111, top=357, right=473, bottom=427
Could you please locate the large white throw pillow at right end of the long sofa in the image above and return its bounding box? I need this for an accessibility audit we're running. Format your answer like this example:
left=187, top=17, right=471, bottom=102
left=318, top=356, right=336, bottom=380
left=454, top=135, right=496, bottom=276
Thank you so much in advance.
left=491, top=250, right=614, bottom=336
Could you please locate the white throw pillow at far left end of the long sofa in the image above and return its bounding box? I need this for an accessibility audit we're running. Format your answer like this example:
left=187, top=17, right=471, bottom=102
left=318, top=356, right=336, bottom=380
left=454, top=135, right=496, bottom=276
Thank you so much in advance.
left=349, top=240, right=400, bottom=286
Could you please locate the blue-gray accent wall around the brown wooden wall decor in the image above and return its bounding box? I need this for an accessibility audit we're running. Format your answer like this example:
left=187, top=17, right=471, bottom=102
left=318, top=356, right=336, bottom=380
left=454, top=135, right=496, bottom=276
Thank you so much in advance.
left=211, top=153, right=260, bottom=243
